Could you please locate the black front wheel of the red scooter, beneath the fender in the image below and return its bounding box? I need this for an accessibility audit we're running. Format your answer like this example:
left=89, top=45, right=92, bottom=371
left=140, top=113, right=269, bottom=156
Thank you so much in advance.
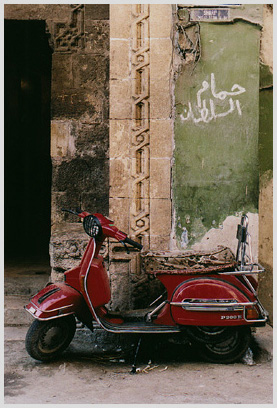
left=25, top=315, right=76, bottom=361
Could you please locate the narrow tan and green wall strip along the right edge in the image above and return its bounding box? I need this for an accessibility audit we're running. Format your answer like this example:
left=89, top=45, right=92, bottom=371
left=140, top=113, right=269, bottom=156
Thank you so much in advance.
left=259, top=4, right=273, bottom=324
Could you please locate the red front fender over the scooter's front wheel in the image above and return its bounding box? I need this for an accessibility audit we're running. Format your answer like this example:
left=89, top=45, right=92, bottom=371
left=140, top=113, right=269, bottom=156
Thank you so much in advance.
left=25, top=283, right=86, bottom=320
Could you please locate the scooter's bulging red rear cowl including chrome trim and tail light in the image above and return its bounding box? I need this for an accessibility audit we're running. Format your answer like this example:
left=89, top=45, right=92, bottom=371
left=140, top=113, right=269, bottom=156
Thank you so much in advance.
left=170, top=276, right=267, bottom=326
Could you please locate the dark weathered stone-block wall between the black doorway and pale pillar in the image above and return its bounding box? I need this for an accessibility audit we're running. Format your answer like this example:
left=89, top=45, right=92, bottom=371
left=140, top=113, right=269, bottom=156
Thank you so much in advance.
left=5, top=4, right=109, bottom=279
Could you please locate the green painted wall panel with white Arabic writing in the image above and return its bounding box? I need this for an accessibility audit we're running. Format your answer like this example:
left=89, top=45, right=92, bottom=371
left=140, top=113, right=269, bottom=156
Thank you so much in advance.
left=173, top=12, right=260, bottom=247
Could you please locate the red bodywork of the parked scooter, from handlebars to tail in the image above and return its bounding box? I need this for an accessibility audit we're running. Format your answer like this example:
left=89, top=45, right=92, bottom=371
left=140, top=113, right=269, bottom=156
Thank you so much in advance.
left=26, top=212, right=267, bottom=364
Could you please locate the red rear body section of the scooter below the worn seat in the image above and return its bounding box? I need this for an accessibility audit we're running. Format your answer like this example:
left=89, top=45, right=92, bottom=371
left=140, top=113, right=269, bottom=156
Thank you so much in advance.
left=157, top=274, right=259, bottom=326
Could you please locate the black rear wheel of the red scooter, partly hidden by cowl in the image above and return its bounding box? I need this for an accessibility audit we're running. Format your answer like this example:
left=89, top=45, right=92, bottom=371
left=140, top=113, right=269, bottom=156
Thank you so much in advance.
left=195, top=326, right=251, bottom=364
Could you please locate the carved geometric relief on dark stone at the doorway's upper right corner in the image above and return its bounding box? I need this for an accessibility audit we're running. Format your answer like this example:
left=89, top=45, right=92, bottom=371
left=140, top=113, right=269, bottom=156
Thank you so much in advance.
left=53, top=4, right=85, bottom=52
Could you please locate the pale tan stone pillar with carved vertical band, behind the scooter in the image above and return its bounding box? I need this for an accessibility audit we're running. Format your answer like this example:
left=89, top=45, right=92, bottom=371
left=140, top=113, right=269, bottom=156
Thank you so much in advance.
left=110, top=4, right=173, bottom=309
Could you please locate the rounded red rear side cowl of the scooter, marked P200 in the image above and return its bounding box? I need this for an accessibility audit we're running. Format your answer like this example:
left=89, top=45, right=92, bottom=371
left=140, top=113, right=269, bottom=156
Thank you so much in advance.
left=171, top=275, right=255, bottom=326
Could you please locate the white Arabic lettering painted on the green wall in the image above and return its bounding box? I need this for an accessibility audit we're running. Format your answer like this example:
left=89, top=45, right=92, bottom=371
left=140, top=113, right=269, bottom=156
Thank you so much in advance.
left=180, top=73, right=246, bottom=123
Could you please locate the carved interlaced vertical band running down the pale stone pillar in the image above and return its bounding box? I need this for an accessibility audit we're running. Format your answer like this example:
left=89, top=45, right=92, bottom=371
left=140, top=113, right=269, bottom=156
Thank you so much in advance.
left=130, top=4, right=150, bottom=245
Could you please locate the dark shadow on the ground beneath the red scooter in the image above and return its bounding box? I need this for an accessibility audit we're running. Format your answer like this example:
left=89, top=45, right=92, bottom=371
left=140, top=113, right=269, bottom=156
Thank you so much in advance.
left=19, top=329, right=271, bottom=366
